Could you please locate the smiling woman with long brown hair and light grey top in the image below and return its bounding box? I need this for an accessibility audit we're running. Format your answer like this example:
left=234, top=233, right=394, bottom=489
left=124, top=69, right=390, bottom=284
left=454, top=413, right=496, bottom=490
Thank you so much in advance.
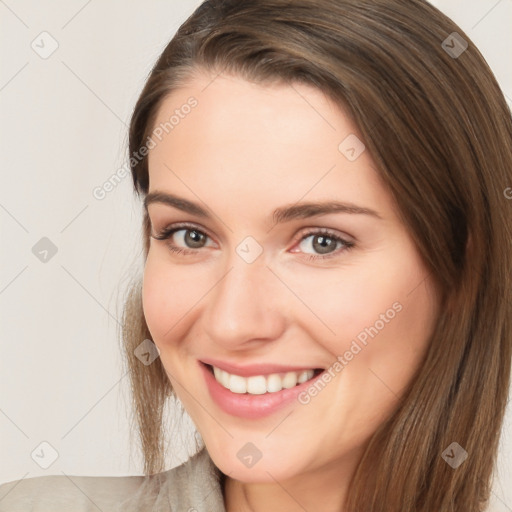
left=0, top=0, right=512, bottom=512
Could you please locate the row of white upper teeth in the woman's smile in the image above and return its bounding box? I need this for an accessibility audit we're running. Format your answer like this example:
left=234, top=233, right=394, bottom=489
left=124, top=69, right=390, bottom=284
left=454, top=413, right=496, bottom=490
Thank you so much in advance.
left=209, top=366, right=315, bottom=395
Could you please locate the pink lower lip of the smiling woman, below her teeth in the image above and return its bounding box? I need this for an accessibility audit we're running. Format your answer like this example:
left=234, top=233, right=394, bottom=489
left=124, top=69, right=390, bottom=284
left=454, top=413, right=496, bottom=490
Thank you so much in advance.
left=199, top=362, right=322, bottom=419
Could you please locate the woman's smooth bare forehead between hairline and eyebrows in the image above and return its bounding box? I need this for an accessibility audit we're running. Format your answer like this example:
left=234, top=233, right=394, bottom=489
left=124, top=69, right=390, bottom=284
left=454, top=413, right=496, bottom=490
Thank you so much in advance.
left=148, top=71, right=391, bottom=222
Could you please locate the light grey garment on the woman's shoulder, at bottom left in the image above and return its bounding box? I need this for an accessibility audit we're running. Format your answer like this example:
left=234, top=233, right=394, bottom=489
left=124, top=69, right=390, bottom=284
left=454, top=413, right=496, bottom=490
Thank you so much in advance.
left=0, top=448, right=226, bottom=512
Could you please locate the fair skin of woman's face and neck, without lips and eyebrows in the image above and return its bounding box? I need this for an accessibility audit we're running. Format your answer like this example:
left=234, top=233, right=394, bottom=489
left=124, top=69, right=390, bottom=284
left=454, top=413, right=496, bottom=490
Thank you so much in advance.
left=143, top=73, right=438, bottom=512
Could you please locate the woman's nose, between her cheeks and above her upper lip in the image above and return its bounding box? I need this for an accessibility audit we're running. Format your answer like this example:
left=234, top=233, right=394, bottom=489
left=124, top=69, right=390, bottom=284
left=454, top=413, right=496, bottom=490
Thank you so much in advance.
left=203, top=254, right=289, bottom=351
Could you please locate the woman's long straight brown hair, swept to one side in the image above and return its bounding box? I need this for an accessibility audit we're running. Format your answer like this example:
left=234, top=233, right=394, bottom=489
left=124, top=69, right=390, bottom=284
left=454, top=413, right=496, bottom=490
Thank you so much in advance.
left=123, top=0, right=512, bottom=512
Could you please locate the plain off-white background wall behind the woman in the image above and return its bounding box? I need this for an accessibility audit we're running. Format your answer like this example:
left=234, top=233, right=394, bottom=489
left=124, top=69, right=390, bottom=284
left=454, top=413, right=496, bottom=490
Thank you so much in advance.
left=0, top=0, right=512, bottom=512
